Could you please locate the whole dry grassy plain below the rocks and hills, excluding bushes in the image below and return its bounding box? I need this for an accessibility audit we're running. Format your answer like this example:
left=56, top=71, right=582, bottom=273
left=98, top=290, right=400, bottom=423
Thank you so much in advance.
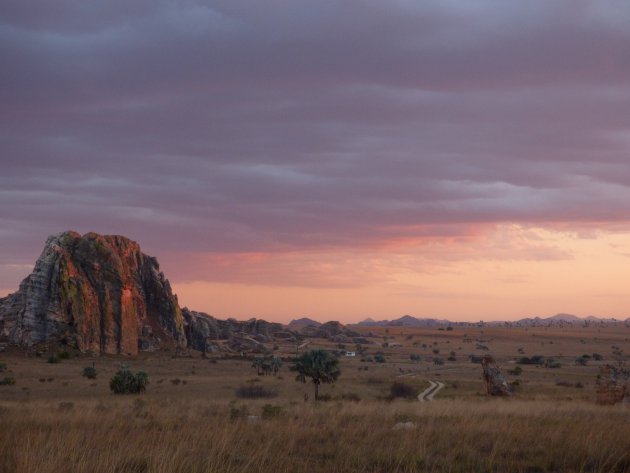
left=0, top=326, right=630, bottom=473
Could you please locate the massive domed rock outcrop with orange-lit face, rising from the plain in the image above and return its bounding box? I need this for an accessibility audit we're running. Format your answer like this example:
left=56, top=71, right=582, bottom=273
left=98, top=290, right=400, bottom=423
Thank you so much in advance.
left=0, top=232, right=187, bottom=355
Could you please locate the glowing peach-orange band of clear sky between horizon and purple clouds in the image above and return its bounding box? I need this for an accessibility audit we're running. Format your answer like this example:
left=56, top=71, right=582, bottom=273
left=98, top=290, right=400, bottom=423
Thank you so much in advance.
left=169, top=225, right=630, bottom=322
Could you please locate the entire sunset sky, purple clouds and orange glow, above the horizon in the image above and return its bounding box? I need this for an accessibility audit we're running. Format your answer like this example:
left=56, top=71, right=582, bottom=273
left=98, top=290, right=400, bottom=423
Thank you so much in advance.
left=0, top=0, right=630, bottom=322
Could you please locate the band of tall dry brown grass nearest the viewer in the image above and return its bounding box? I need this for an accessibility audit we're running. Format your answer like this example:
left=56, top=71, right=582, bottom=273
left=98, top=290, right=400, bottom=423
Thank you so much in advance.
left=0, top=396, right=630, bottom=473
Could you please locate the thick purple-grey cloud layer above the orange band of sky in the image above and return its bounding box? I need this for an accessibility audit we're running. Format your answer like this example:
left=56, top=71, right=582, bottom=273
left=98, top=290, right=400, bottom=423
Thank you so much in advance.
left=0, top=0, right=630, bottom=287
